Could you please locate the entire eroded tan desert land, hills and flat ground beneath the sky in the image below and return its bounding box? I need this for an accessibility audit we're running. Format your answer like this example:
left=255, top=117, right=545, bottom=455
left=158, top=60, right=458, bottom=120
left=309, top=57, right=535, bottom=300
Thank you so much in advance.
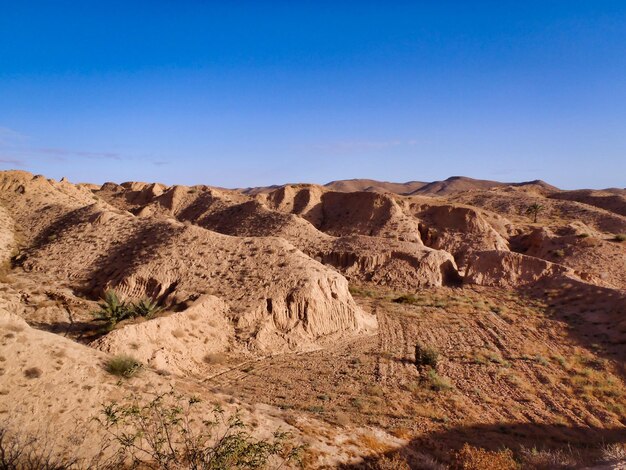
left=0, top=171, right=626, bottom=469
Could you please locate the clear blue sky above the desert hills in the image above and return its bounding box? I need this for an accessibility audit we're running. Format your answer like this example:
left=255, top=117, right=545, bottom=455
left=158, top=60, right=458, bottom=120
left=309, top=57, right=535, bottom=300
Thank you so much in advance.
left=0, top=0, right=626, bottom=188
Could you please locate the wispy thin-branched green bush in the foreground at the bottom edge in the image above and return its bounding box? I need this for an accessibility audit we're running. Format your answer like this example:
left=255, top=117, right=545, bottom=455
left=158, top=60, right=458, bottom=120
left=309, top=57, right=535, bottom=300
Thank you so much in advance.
left=97, top=392, right=303, bottom=470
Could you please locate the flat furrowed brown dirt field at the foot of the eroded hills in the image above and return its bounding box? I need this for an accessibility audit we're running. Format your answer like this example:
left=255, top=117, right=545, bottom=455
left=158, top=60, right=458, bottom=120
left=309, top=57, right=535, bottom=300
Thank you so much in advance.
left=204, top=286, right=626, bottom=461
